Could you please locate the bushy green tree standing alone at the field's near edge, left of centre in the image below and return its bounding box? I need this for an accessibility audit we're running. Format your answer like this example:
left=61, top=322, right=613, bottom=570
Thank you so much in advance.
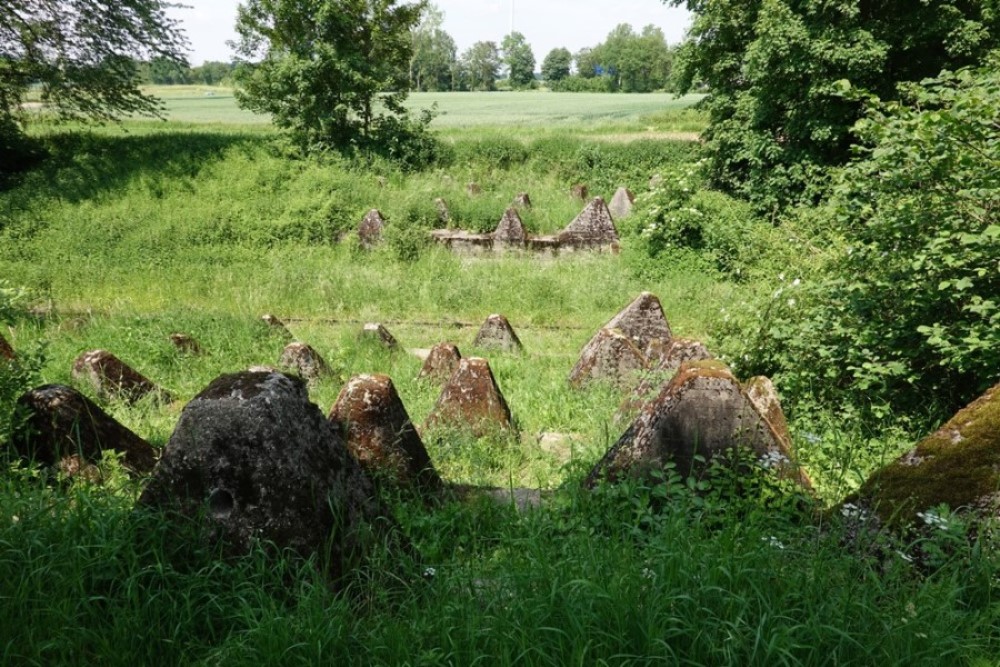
left=234, top=0, right=425, bottom=150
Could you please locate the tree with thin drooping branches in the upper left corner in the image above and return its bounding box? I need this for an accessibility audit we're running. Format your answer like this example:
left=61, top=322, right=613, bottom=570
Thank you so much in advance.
left=0, top=0, right=187, bottom=157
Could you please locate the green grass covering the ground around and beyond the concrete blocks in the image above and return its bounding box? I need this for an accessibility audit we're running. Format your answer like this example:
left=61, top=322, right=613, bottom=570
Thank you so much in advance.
left=0, top=88, right=1000, bottom=667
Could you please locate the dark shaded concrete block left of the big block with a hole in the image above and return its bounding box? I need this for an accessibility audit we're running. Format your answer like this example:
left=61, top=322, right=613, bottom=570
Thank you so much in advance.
left=11, top=384, right=156, bottom=476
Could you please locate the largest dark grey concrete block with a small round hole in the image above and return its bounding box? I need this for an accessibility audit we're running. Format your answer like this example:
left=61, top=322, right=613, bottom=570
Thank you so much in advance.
left=139, top=372, right=401, bottom=579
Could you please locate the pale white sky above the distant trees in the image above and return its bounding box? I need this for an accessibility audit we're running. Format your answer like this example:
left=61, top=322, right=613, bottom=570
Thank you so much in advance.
left=170, top=0, right=689, bottom=69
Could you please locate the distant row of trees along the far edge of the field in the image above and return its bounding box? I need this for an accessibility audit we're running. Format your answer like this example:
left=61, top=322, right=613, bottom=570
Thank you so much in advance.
left=408, top=5, right=674, bottom=93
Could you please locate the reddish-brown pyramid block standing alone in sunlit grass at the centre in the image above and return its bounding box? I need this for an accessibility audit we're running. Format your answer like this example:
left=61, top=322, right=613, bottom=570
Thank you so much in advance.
left=425, top=357, right=513, bottom=437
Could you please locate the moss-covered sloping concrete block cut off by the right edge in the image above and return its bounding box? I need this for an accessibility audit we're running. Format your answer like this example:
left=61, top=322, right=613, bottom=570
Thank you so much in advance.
left=847, top=384, right=1000, bottom=528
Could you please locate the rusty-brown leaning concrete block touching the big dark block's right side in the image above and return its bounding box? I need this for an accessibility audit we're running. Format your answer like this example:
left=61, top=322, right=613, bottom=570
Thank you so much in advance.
left=329, top=375, right=442, bottom=493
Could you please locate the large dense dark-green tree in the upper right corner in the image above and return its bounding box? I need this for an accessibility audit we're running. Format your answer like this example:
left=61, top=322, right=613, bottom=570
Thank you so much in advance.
left=664, top=0, right=1000, bottom=212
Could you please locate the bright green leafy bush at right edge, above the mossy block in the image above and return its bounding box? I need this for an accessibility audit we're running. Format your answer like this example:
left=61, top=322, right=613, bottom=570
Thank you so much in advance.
left=732, top=61, right=1000, bottom=417
